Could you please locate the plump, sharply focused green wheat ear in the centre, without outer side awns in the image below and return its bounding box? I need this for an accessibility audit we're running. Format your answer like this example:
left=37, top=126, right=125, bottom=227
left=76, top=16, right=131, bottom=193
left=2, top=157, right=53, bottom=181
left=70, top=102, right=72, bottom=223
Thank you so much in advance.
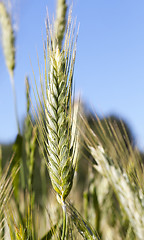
left=45, top=11, right=78, bottom=204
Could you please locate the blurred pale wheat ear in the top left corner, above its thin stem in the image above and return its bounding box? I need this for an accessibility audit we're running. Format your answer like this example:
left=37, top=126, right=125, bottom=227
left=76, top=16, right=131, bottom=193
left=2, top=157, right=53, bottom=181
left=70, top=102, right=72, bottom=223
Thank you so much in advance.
left=0, top=2, right=15, bottom=75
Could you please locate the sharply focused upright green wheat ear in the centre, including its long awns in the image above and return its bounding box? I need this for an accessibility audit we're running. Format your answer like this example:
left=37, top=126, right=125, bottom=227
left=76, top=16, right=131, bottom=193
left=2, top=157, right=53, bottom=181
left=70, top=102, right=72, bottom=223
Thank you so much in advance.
left=32, top=9, right=78, bottom=209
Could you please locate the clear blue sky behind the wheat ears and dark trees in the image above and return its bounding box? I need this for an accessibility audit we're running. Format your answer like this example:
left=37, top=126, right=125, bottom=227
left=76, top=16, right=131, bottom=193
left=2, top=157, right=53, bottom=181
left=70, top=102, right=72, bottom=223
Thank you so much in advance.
left=0, top=0, right=144, bottom=148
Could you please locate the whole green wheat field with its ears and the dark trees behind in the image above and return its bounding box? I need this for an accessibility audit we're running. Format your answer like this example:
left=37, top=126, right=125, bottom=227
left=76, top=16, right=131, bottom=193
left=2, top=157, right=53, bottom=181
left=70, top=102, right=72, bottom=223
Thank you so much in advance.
left=0, top=0, right=144, bottom=240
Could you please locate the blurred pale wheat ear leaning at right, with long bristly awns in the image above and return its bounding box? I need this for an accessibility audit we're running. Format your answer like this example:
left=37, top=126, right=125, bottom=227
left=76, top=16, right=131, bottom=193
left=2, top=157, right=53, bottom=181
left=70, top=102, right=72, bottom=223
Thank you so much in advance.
left=83, top=115, right=144, bottom=240
